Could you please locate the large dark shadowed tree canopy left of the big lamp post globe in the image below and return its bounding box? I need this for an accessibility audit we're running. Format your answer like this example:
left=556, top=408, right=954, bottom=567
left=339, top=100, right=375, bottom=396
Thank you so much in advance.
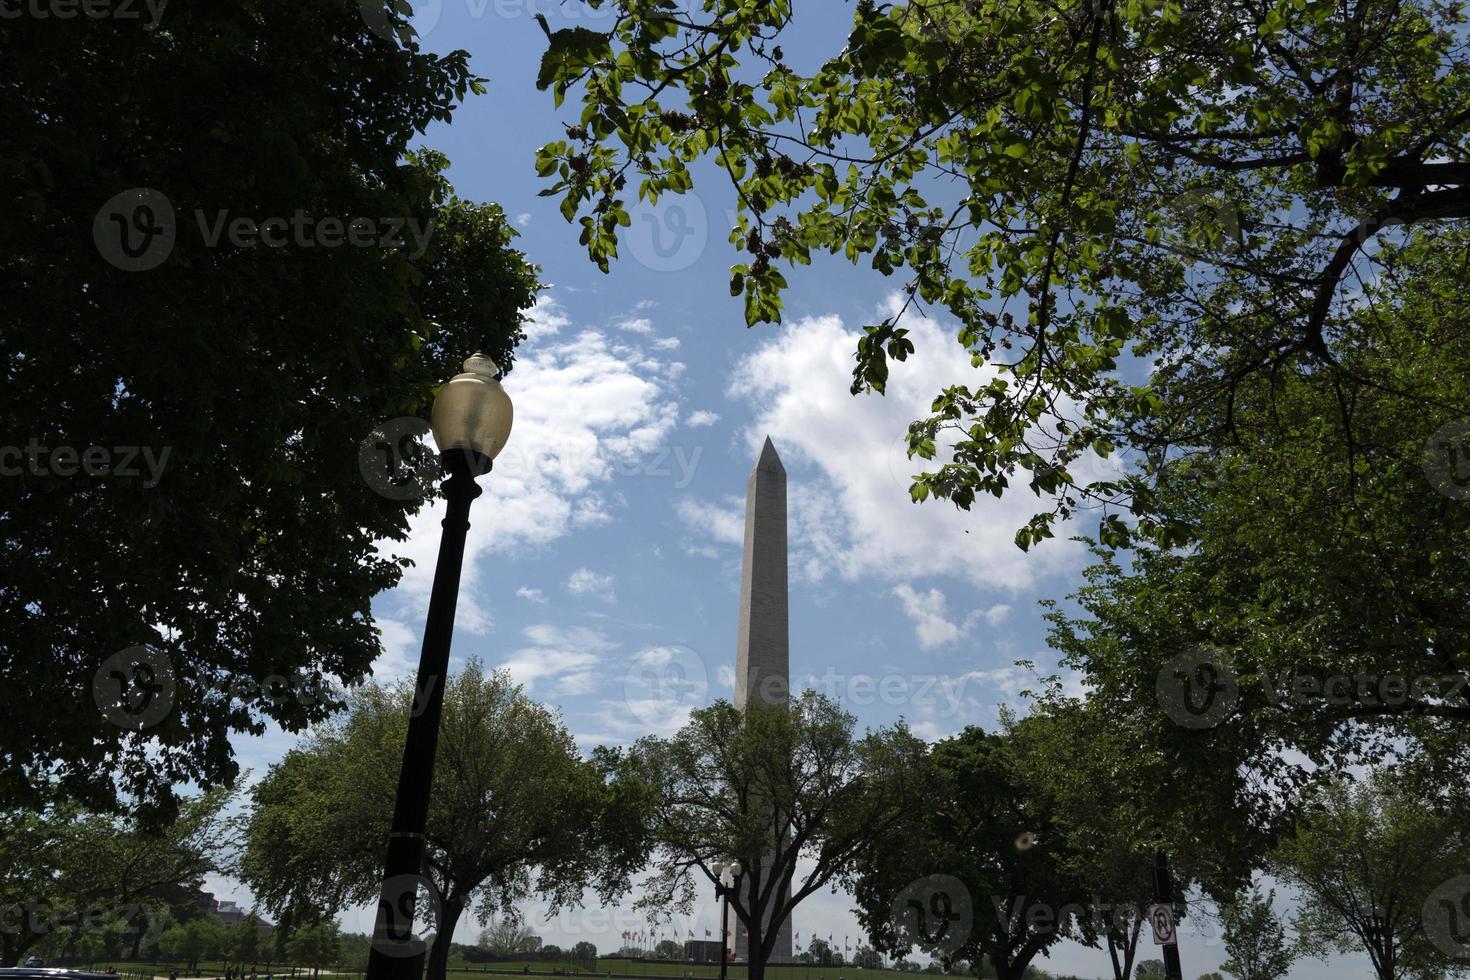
left=0, top=0, right=537, bottom=811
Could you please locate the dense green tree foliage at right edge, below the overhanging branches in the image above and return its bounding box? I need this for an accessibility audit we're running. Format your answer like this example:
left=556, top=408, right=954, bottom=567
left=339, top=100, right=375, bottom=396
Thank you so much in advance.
left=1051, top=232, right=1470, bottom=799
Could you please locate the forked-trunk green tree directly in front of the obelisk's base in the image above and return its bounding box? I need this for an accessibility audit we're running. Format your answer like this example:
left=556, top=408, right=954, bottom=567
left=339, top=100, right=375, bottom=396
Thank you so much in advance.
left=623, top=691, right=923, bottom=980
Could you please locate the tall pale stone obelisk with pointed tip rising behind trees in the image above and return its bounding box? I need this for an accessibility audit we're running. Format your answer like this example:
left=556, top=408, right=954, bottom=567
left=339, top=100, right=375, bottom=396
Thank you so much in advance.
left=731, top=436, right=792, bottom=962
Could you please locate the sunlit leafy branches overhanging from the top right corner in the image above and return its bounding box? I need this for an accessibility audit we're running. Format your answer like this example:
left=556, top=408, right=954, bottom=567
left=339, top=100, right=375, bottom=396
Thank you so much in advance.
left=537, top=0, right=1470, bottom=547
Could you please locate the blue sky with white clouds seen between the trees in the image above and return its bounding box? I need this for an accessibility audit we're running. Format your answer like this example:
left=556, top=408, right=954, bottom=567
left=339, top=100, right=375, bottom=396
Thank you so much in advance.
left=212, top=0, right=1366, bottom=977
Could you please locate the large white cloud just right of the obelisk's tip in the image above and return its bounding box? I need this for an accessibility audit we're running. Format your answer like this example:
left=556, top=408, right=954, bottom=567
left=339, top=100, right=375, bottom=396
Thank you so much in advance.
left=684, top=299, right=1085, bottom=592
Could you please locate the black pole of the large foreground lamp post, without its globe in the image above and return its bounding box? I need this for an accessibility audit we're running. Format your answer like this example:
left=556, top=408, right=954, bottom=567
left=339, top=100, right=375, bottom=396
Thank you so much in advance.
left=368, top=450, right=490, bottom=980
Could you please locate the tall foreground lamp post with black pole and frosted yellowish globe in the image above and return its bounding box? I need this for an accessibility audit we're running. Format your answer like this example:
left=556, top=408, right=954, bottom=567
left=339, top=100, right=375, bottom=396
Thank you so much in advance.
left=368, top=354, right=513, bottom=980
